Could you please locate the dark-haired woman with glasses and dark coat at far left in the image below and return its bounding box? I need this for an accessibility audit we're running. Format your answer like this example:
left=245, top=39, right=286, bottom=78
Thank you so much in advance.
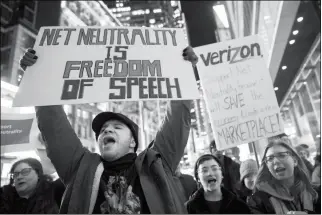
left=0, top=158, right=65, bottom=214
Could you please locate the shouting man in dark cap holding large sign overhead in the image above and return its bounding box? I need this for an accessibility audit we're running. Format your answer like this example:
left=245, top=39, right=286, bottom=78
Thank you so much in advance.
left=20, top=47, right=198, bottom=214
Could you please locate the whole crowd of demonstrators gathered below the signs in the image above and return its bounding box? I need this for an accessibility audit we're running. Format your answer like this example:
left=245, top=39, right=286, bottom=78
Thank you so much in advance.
left=11, top=44, right=321, bottom=214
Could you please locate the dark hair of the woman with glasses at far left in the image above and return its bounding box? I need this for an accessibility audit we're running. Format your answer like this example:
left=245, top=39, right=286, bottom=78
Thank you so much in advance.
left=9, top=158, right=53, bottom=185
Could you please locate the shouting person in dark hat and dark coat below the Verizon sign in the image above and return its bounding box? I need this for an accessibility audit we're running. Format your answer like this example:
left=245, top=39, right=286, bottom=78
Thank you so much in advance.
left=186, top=154, right=250, bottom=214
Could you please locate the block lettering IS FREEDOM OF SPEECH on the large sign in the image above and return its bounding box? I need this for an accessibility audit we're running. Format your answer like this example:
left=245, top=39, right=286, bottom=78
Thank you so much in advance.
left=61, top=46, right=182, bottom=100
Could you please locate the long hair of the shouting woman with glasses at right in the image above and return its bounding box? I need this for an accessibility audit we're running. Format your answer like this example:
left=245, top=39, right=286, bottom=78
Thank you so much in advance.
left=254, top=138, right=315, bottom=196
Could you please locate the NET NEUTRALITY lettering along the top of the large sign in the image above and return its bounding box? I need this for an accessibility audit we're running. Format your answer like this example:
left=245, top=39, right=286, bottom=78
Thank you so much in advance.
left=39, top=28, right=177, bottom=46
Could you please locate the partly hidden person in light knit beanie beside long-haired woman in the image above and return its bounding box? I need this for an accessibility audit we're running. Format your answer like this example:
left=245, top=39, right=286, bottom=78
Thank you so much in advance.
left=237, top=159, right=258, bottom=202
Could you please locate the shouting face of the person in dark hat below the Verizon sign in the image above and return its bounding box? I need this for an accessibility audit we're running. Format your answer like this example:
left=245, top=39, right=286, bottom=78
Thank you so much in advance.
left=198, top=159, right=223, bottom=192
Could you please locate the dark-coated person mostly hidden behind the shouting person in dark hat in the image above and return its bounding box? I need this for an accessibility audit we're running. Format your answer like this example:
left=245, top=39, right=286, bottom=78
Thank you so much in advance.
left=209, top=140, right=240, bottom=194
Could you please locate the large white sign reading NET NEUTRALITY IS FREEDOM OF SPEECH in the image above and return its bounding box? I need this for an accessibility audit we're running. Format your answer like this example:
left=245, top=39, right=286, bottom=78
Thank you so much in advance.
left=13, top=27, right=199, bottom=107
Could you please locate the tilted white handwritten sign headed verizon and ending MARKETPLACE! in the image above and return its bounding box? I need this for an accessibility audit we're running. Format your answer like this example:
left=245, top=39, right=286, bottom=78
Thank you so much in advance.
left=195, top=36, right=283, bottom=150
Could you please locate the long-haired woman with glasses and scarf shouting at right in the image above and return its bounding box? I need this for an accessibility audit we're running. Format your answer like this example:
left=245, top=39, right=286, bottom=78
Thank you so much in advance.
left=248, top=139, right=321, bottom=214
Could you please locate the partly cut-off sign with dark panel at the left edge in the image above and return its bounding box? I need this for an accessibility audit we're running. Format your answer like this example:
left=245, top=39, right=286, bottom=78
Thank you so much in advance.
left=1, top=113, right=37, bottom=153
